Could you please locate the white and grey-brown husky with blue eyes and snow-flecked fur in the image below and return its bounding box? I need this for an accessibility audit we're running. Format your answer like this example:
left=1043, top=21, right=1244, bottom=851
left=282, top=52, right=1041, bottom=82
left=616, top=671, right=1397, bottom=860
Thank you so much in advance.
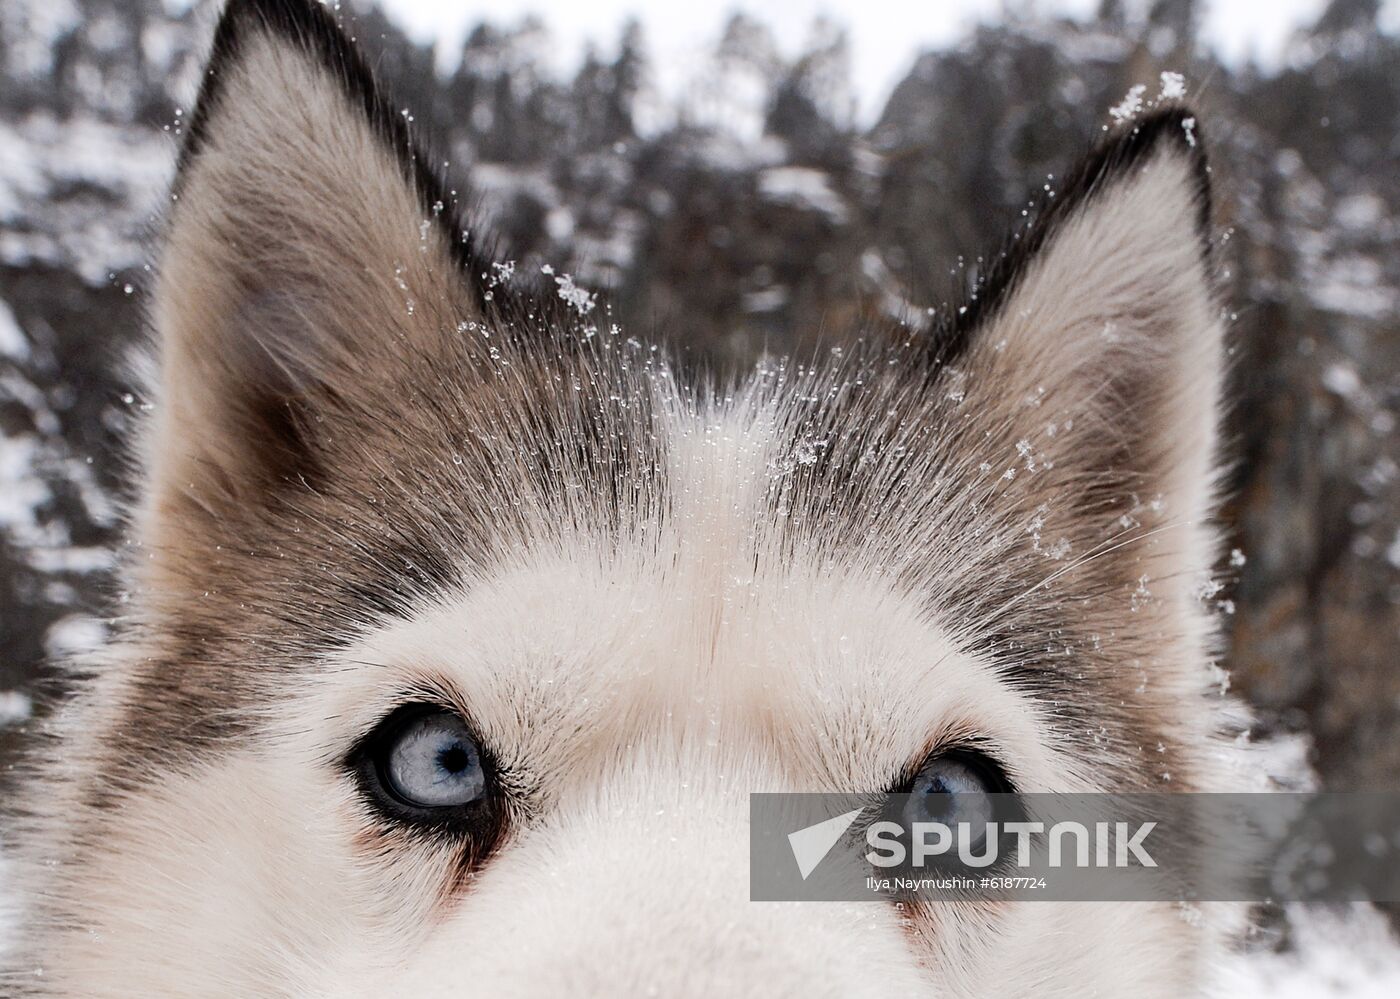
left=8, top=0, right=1222, bottom=999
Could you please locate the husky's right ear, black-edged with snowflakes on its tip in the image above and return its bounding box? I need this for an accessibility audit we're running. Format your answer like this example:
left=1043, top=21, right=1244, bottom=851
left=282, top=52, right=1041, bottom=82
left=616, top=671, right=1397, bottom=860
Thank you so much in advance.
left=934, top=108, right=1222, bottom=537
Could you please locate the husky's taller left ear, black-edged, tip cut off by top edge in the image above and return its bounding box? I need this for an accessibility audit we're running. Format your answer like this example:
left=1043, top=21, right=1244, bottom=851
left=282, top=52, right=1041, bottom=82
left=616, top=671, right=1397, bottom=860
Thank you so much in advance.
left=147, top=0, right=482, bottom=522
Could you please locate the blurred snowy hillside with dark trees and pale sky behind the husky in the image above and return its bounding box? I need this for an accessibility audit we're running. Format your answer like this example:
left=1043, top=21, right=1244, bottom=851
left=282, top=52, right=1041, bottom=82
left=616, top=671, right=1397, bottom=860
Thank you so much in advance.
left=0, top=0, right=1400, bottom=995
